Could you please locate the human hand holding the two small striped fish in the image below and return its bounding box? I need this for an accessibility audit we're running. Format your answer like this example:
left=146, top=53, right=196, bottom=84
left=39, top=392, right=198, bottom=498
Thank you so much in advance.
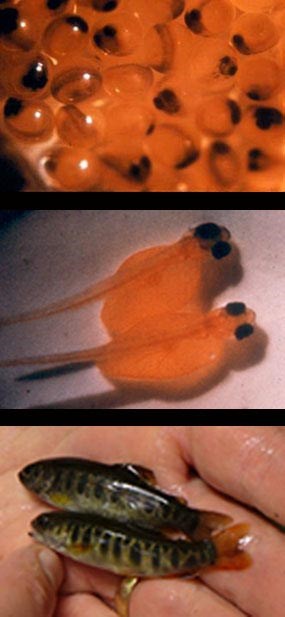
left=0, top=426, right=285, bottom=617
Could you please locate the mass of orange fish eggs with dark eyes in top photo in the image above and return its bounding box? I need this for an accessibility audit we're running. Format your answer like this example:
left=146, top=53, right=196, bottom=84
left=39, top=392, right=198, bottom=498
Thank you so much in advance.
left=0, top=0, right=285, bottom=192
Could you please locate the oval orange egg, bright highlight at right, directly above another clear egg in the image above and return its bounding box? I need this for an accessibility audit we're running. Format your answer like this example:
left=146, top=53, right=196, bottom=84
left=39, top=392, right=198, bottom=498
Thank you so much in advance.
left=51, top=64, right=102, bottom=104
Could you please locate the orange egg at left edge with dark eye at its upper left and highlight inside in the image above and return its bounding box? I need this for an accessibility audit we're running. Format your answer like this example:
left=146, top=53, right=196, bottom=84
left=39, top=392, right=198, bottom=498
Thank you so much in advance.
left=3, top=98, right=54, bottom=141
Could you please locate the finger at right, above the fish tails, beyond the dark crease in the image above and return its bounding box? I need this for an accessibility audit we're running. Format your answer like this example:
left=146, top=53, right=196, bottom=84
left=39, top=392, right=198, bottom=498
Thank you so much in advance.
left=181, top=426, right=285, bottom=524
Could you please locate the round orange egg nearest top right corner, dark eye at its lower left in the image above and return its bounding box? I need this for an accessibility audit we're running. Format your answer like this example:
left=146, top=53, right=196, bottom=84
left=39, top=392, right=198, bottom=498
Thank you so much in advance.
left=231, top=13, right=278, bottom=55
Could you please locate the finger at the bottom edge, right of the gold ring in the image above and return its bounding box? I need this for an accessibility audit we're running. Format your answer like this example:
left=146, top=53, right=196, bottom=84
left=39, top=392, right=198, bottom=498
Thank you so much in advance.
left=130, top=580, right=245, bottom=617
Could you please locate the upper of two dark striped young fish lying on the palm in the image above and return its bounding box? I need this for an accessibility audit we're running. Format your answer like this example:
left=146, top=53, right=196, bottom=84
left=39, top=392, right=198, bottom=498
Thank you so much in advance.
left=19, top=458, right=232, bottom=540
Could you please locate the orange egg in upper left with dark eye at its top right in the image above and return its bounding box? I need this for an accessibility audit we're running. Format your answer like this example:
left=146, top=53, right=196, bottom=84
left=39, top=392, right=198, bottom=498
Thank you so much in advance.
left=43, top=14, right=89, bottom=58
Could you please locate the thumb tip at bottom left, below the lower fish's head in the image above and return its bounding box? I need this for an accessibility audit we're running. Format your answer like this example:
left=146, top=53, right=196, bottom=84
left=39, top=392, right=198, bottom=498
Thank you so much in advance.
left=0, top=546, right=63, bottom=617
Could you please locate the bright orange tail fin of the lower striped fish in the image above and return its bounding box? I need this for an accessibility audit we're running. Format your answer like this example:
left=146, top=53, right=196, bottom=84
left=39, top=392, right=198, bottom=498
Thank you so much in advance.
left=213, top=523, right=251, bottom=570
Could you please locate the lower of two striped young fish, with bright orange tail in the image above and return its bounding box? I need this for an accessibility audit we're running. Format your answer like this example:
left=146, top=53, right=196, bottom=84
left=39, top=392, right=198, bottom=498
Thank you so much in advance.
left=30, top=512, right=248, bottom=577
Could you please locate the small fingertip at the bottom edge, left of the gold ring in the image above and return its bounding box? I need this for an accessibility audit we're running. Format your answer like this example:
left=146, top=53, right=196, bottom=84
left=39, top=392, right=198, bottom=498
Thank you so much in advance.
left=54, top=593, right=116, bottom=617
